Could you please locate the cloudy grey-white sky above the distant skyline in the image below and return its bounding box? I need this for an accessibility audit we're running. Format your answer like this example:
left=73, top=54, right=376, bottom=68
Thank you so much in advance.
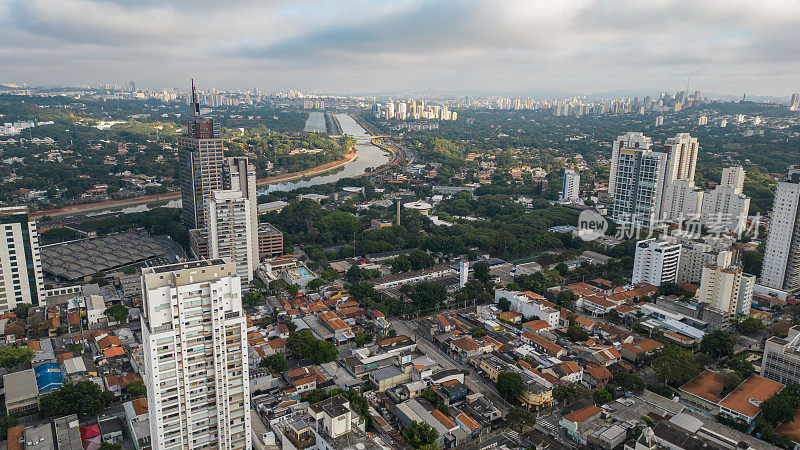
left=0, top=0, right=800, bottom=97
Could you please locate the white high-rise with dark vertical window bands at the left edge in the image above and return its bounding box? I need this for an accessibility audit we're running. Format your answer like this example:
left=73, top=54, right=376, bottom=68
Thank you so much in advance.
left=0, top=206, right=44, bottom=314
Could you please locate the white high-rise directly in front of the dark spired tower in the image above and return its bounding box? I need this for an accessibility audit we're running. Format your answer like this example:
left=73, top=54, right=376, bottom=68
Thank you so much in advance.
left=206, top=190, right=259, bottom=285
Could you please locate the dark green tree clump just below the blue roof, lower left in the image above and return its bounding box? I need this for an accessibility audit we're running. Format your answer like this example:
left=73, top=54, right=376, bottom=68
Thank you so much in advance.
left=40, top=380, right=108, bottom=417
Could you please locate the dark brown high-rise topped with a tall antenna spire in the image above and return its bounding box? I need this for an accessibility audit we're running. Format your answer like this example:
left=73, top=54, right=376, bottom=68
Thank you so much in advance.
left=178, top=82, right=225, bottom=230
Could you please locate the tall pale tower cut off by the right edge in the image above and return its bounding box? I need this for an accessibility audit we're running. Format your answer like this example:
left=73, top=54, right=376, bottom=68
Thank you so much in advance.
left=761, top=165, right=800, bottom=291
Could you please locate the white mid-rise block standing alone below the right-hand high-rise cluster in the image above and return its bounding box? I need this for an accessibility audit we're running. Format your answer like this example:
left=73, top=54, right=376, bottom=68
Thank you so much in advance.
left=631, top=238, right=681, bottom=286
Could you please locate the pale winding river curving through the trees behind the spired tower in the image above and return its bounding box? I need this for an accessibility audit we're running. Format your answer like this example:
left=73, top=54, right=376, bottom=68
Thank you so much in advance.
left=258, top=112, right=391, bottom=195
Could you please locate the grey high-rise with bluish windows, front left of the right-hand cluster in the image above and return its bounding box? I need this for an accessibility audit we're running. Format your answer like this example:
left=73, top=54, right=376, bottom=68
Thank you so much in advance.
left=609, top=144, right=667, bottom=226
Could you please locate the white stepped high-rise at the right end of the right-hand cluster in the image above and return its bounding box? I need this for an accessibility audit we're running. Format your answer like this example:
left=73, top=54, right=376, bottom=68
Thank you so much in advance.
left=700, top=167, right=750, bottom=233
